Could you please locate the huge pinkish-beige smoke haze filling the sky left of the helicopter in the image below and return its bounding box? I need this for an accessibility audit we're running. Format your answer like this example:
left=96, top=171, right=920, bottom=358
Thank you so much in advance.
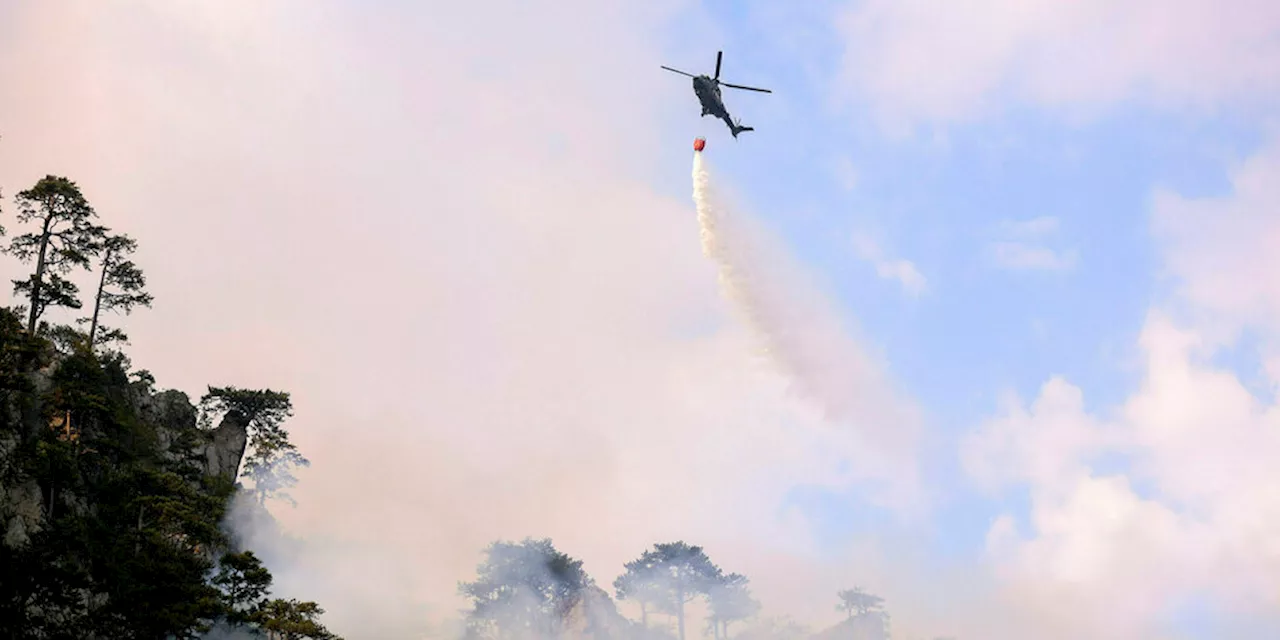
left=0, top=1, right=957, bottom=637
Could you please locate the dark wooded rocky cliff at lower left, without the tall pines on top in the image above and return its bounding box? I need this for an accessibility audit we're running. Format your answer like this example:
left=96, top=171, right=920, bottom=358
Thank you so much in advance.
left=0, top=317, right=268, bottom=640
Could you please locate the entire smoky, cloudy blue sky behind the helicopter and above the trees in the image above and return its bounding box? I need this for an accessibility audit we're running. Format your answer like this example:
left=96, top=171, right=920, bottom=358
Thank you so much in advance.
left=0, top=0, right=1280, bottom=640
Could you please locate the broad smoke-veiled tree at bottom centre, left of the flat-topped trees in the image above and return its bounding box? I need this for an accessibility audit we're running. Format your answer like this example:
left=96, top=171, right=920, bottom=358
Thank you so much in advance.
left=458, top=539, right=594, bottom=637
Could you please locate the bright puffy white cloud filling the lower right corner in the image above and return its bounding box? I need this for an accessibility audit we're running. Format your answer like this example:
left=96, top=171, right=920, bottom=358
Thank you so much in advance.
left=966, top=315, right=1280, bottom=639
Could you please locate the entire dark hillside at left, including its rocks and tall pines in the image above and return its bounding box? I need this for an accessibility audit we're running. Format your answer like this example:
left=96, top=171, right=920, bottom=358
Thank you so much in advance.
left=0, top=175, right=335, bottom=640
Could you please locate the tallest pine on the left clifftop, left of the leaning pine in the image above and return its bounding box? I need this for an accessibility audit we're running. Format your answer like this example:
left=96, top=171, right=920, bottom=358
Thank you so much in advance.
left=8, top=175, right=104, bottom=333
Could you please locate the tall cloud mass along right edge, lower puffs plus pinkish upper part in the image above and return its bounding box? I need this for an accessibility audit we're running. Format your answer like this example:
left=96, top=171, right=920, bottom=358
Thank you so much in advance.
left=964, top=136, right=1280, bottom=639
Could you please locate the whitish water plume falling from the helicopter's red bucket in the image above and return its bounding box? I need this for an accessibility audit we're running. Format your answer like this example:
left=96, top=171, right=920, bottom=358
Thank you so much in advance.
left=692, top=152, right=919, bottom=481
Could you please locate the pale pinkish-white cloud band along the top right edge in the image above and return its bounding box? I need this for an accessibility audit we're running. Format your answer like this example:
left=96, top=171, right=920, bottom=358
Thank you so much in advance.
left=838, top=0, right=1280, bottom=125
